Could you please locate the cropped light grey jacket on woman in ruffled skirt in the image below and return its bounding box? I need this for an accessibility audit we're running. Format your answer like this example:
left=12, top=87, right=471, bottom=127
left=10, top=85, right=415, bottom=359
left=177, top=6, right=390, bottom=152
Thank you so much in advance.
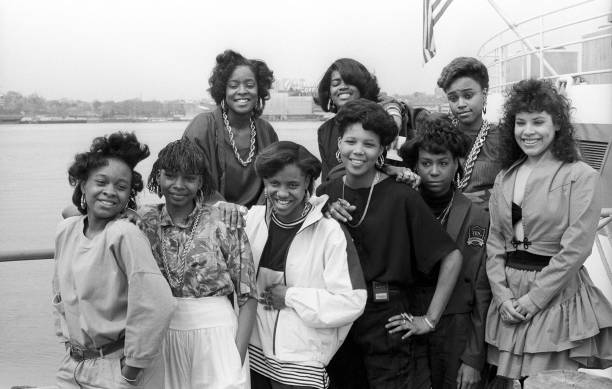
left=487, top=152, right=601, bottom=309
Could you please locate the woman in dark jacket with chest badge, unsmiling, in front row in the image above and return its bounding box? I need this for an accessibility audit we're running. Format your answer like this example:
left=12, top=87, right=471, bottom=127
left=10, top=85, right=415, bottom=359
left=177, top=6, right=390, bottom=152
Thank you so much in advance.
left=399, top=114, right=491, bottom=389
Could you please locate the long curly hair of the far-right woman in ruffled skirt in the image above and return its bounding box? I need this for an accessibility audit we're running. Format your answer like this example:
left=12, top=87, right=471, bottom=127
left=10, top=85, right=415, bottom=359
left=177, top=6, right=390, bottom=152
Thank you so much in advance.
left=500, top=79, right=580, bottom=168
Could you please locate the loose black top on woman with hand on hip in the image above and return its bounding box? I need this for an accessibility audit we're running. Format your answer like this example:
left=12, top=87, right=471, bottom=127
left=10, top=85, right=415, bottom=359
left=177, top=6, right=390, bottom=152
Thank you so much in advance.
left=317, top=178, right=457, bottom=287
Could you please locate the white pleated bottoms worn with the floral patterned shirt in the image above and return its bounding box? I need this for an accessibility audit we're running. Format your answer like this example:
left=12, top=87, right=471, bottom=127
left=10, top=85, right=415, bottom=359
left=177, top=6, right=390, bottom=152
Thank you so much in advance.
left=162, top=297, right=250, bottom=389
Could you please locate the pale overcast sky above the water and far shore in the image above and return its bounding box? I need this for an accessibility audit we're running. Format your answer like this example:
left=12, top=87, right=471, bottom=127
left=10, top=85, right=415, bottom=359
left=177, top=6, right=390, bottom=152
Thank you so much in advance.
left=0, top=0, right=604, bottom=101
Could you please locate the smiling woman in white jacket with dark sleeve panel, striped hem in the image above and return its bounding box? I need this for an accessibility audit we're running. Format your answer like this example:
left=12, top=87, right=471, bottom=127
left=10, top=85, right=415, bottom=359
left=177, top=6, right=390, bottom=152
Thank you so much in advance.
left=246, top=142, right=366, bottom=389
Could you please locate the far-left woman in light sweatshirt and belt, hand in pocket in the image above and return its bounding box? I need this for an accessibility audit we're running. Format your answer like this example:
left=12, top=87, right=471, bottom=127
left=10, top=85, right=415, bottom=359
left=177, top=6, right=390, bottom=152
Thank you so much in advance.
left=53, top=132, right=174, bottom=389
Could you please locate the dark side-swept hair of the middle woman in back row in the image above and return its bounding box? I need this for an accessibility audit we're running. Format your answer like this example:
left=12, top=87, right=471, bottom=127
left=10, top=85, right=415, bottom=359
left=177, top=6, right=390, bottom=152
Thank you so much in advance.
left=315, top=58, right=380, bottom=113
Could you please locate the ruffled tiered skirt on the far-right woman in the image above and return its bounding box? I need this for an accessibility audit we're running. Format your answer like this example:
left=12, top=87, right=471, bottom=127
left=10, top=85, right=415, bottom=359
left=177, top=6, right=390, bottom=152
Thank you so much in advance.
left=485, top=267, right=612, bottom=379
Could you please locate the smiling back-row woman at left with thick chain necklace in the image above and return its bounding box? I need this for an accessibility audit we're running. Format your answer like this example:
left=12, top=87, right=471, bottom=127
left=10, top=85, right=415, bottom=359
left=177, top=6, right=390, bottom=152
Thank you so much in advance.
left=183, top=50, right=278, bottom=207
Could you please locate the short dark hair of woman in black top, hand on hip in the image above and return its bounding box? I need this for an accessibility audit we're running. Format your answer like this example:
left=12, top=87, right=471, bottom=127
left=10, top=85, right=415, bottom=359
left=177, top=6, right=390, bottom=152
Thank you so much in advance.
left=334, top=99, right=397, bottom=147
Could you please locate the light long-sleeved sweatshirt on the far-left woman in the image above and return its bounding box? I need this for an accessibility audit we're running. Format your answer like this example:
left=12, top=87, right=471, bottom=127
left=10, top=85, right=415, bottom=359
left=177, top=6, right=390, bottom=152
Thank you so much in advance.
left=53, top=216, right=175, bottom=368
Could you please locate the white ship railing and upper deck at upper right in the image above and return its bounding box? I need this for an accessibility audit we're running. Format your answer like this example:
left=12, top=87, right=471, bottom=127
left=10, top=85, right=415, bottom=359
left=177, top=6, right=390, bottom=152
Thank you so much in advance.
left=478, top=0, right=612, bottom=92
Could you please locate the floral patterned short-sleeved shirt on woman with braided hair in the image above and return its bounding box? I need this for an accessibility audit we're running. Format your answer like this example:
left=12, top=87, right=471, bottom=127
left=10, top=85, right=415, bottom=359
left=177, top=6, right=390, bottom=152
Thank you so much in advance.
left=138, top=204, right=257, bottom=305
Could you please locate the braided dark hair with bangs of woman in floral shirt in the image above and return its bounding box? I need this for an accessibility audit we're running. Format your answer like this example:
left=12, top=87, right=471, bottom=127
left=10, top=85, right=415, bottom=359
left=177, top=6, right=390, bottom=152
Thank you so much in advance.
left=147, top=138, right=214, bottom=199
